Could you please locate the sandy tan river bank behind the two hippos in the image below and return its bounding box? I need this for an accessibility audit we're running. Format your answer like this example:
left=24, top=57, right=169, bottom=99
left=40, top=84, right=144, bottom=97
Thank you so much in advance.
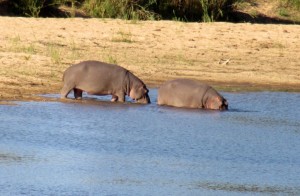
left=0, top=17, right=300, bottom=100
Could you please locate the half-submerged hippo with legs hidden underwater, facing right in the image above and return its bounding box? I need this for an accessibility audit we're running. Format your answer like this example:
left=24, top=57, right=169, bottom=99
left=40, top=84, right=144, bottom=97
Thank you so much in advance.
left=157, top=79, right=228, bottom=110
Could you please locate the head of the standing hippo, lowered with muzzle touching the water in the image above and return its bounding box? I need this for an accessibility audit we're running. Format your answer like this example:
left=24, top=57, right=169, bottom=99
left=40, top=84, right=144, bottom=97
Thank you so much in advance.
left=129, top=84, right=150, bottom=104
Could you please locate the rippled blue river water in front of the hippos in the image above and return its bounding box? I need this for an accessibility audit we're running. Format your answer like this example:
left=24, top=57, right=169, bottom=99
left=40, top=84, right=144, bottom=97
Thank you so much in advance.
left=0, top=89, right=300, bottom=195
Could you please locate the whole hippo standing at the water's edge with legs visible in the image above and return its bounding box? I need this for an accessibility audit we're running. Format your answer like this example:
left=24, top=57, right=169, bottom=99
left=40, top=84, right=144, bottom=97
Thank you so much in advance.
left=61, top=61, right=150, bottom=104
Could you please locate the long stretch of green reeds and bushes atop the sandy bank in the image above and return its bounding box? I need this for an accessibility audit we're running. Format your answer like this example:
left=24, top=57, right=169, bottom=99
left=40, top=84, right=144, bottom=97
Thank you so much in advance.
left=9, top=0, right=241, bottom=22
